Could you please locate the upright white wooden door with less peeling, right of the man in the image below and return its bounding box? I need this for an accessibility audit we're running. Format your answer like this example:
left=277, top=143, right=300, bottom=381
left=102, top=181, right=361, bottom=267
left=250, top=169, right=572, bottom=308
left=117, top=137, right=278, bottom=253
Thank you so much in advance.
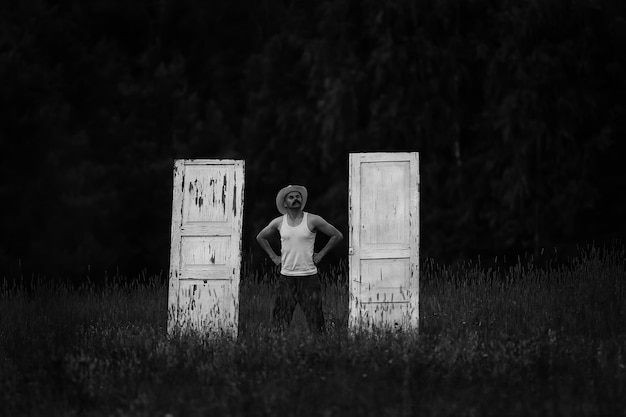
left=349, top=152, right=419, bottom=329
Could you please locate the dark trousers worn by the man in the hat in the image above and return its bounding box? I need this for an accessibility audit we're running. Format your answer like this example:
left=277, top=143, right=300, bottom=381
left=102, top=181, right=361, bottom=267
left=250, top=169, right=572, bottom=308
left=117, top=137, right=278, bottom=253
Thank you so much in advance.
left=272, top=274, right=324, bottom=333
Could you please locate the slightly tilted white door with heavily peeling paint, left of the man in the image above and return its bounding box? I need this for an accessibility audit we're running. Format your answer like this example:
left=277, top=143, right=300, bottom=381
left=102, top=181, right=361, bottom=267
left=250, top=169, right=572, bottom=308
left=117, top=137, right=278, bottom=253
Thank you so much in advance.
left=168, top=159, right=244, bottom=337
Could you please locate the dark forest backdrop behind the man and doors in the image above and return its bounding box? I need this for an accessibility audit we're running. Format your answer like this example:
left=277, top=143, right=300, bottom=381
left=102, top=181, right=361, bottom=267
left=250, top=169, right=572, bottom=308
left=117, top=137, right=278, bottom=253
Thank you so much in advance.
left=0, top=0, right=626, bottom=277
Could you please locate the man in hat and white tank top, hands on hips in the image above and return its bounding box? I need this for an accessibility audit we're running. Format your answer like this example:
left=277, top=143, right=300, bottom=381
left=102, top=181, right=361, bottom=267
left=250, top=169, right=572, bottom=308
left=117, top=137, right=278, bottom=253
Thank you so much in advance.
left=256, top=185, right=343, bottom=333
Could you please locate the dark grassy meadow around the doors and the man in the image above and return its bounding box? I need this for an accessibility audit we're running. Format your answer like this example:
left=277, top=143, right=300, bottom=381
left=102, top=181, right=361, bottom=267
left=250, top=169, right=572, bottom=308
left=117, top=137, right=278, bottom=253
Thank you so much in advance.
left=0, top=245, right=626, bottom=416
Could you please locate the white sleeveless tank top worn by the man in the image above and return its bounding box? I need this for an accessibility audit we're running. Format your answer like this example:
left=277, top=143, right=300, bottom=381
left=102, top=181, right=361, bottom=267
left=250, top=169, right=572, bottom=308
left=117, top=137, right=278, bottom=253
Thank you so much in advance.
left=279, top=212, right=317, bottom=277
